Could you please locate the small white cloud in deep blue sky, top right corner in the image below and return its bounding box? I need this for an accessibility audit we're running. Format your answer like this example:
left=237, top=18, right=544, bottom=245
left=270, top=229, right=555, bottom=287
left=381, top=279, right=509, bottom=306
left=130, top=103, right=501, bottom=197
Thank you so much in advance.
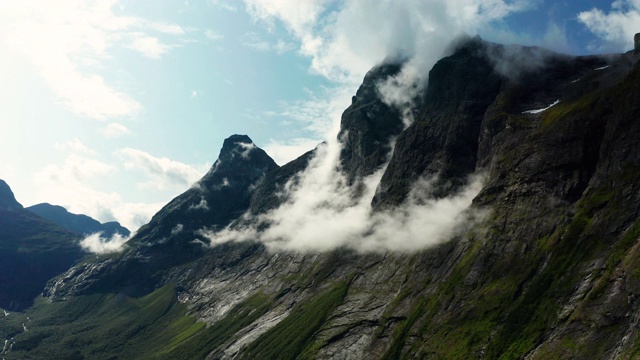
left=578, top=0, right=640, bottom=51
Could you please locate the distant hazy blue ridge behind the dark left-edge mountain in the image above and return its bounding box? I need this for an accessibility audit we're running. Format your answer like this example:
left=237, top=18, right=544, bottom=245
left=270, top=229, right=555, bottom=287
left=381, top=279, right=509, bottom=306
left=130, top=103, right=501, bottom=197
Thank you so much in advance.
left=26, top=203, right=131, bottom=238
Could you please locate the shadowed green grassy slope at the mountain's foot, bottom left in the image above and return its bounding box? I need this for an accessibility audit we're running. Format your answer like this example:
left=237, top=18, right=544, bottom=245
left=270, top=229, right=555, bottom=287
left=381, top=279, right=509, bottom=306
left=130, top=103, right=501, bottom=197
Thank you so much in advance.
left=5, top=285, right=204, bottom=360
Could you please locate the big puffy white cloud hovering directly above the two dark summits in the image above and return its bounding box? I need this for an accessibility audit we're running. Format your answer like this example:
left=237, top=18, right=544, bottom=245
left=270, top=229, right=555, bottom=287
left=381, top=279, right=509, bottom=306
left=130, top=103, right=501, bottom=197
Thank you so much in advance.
left=245, top=0, right=535, bottom=82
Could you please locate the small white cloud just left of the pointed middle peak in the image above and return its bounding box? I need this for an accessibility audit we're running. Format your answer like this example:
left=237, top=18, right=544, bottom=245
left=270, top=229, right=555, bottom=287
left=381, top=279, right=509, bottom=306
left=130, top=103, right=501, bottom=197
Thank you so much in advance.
left=116, top=148, right=205, bottom=190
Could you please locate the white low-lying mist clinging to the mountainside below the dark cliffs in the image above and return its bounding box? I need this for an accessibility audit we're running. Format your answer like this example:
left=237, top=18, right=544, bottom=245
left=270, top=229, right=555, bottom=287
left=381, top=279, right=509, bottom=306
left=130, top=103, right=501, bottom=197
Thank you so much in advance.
left=198, top=134, right=483, bottom=252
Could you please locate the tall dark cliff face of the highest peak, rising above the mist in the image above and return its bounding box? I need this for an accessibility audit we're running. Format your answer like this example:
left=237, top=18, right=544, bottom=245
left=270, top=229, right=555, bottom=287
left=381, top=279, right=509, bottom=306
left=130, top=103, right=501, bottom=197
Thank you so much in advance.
left=373, top=39, right=502, bottom=207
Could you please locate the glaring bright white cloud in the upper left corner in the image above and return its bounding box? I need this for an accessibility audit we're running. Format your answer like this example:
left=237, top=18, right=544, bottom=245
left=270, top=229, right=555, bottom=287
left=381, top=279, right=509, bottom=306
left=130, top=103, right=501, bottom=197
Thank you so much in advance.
left=0, top=0, right=184, bottom=120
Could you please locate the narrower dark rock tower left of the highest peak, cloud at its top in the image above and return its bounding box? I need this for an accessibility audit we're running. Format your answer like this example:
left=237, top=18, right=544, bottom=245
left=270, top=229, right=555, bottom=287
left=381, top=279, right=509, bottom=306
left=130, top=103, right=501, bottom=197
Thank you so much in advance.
left=338, top=64, right=404, bottom=184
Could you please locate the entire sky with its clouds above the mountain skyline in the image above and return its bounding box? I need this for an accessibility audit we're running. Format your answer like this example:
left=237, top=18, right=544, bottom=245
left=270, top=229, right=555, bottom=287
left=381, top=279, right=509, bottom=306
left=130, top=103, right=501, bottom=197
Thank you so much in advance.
left=0, top=0, right=640, bottom=230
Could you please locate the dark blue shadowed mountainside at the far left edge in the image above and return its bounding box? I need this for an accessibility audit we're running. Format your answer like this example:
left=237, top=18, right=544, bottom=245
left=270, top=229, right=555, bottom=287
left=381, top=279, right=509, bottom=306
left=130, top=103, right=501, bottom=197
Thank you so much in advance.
left=0, top=180, right=85, bottom=310
